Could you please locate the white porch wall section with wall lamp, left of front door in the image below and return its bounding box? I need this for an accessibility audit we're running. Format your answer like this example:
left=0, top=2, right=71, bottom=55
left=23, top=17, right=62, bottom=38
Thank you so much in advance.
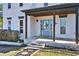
left=27, top=16, right=40, bottom=38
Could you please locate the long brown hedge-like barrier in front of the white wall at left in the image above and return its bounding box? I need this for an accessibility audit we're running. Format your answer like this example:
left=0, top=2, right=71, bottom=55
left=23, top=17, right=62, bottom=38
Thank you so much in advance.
left=0, top=30, right=19, bottom=42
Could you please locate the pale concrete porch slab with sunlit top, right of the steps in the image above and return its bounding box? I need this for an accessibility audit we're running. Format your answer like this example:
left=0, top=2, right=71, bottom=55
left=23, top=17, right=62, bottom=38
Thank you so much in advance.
left=33, top=38, right=79, bottom=50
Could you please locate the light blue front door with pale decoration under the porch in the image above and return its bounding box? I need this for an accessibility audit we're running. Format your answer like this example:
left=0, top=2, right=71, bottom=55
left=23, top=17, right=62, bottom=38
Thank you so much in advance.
left=41, top=19, right=52, bottom=38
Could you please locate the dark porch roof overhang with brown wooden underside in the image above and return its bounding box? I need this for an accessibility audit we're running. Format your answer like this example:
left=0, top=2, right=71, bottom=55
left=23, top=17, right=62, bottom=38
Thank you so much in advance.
left=22, top=3, right=79, bottom=16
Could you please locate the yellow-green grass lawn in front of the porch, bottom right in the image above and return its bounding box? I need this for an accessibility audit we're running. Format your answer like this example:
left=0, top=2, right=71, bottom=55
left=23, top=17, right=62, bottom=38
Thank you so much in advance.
left=33, top=49, right=79, bottom=56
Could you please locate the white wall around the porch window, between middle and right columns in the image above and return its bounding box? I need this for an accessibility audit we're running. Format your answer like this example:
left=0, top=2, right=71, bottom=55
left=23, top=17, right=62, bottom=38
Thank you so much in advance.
left=55, top=14, right=76, bottom=39
